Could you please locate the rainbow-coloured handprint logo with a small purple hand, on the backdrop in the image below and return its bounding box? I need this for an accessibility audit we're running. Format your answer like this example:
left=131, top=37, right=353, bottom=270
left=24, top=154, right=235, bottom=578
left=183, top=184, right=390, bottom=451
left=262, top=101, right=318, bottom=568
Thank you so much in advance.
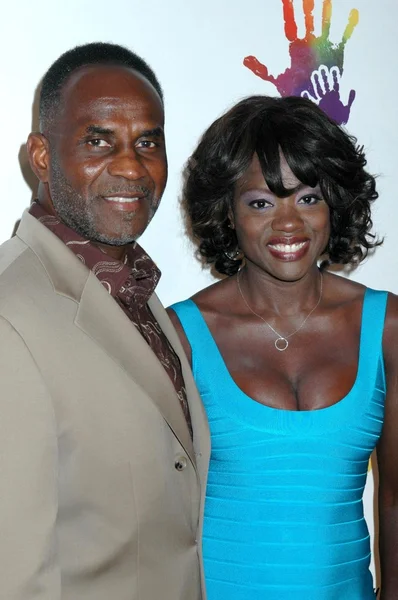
left=243, top=0, right=359, bottom=125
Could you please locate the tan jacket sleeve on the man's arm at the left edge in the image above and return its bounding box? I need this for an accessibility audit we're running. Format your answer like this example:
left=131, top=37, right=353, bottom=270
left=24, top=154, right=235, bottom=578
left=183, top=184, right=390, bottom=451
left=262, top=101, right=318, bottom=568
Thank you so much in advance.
left=0, top=317, right=61, bottom=600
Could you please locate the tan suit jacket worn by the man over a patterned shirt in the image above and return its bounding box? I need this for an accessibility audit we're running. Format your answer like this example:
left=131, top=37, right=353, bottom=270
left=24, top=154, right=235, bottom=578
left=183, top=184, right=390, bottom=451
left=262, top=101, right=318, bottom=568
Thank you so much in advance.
left=0, top=213, right=210, bottom=600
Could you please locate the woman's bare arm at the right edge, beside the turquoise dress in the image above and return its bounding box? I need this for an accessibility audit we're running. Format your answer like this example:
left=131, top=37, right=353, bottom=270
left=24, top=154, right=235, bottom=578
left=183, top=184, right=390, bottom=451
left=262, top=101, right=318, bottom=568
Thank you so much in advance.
left=377, top=294, right=398, bottom=600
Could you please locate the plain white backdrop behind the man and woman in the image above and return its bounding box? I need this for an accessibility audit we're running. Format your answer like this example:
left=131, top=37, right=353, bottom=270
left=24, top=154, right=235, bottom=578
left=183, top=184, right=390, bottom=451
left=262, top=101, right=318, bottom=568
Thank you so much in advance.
left=0, top=0, right=398, bottom=584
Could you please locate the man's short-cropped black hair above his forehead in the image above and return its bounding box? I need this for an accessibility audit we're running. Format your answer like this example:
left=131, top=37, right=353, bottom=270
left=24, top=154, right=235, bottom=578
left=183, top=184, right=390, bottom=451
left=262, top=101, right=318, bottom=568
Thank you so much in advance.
left=39, top=42, right=163, bottom=131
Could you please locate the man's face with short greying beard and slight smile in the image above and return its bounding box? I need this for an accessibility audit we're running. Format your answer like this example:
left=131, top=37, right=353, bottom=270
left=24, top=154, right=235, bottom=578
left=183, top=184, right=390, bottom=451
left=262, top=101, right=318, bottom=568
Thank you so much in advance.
left=40, top=65, right=167, bottom=246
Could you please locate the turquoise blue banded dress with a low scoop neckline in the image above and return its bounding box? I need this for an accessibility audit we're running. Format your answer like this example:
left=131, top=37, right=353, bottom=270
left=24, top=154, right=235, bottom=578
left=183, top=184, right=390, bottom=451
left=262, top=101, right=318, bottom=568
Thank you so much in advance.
left=172, top=289, right=387, bottom=600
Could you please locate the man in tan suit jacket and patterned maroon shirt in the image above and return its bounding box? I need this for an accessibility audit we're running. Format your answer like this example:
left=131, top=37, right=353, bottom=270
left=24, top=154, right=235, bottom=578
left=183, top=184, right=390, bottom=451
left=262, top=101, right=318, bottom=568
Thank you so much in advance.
left=0, top=43, right=209, bottom=600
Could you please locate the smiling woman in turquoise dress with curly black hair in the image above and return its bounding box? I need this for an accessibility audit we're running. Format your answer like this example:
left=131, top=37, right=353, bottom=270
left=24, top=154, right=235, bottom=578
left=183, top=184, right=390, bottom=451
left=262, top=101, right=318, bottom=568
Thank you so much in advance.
left=170, top=96, right=398, bottom=600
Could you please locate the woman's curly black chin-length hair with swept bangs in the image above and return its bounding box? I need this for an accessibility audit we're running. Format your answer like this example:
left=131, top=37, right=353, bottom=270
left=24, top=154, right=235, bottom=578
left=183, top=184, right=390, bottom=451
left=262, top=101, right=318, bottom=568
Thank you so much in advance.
left=183, top=96, right=382, bottom=275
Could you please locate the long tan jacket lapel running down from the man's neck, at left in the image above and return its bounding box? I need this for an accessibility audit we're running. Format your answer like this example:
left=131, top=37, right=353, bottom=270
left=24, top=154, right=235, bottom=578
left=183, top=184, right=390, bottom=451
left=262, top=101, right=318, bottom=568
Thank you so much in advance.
left=17, top=212, right=196, bottom=468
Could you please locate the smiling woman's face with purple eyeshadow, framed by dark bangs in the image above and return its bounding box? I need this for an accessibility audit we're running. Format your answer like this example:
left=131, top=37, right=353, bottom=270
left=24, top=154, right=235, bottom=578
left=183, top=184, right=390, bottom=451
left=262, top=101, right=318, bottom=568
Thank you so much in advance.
left=231, top=155, right=330, bottom=281
